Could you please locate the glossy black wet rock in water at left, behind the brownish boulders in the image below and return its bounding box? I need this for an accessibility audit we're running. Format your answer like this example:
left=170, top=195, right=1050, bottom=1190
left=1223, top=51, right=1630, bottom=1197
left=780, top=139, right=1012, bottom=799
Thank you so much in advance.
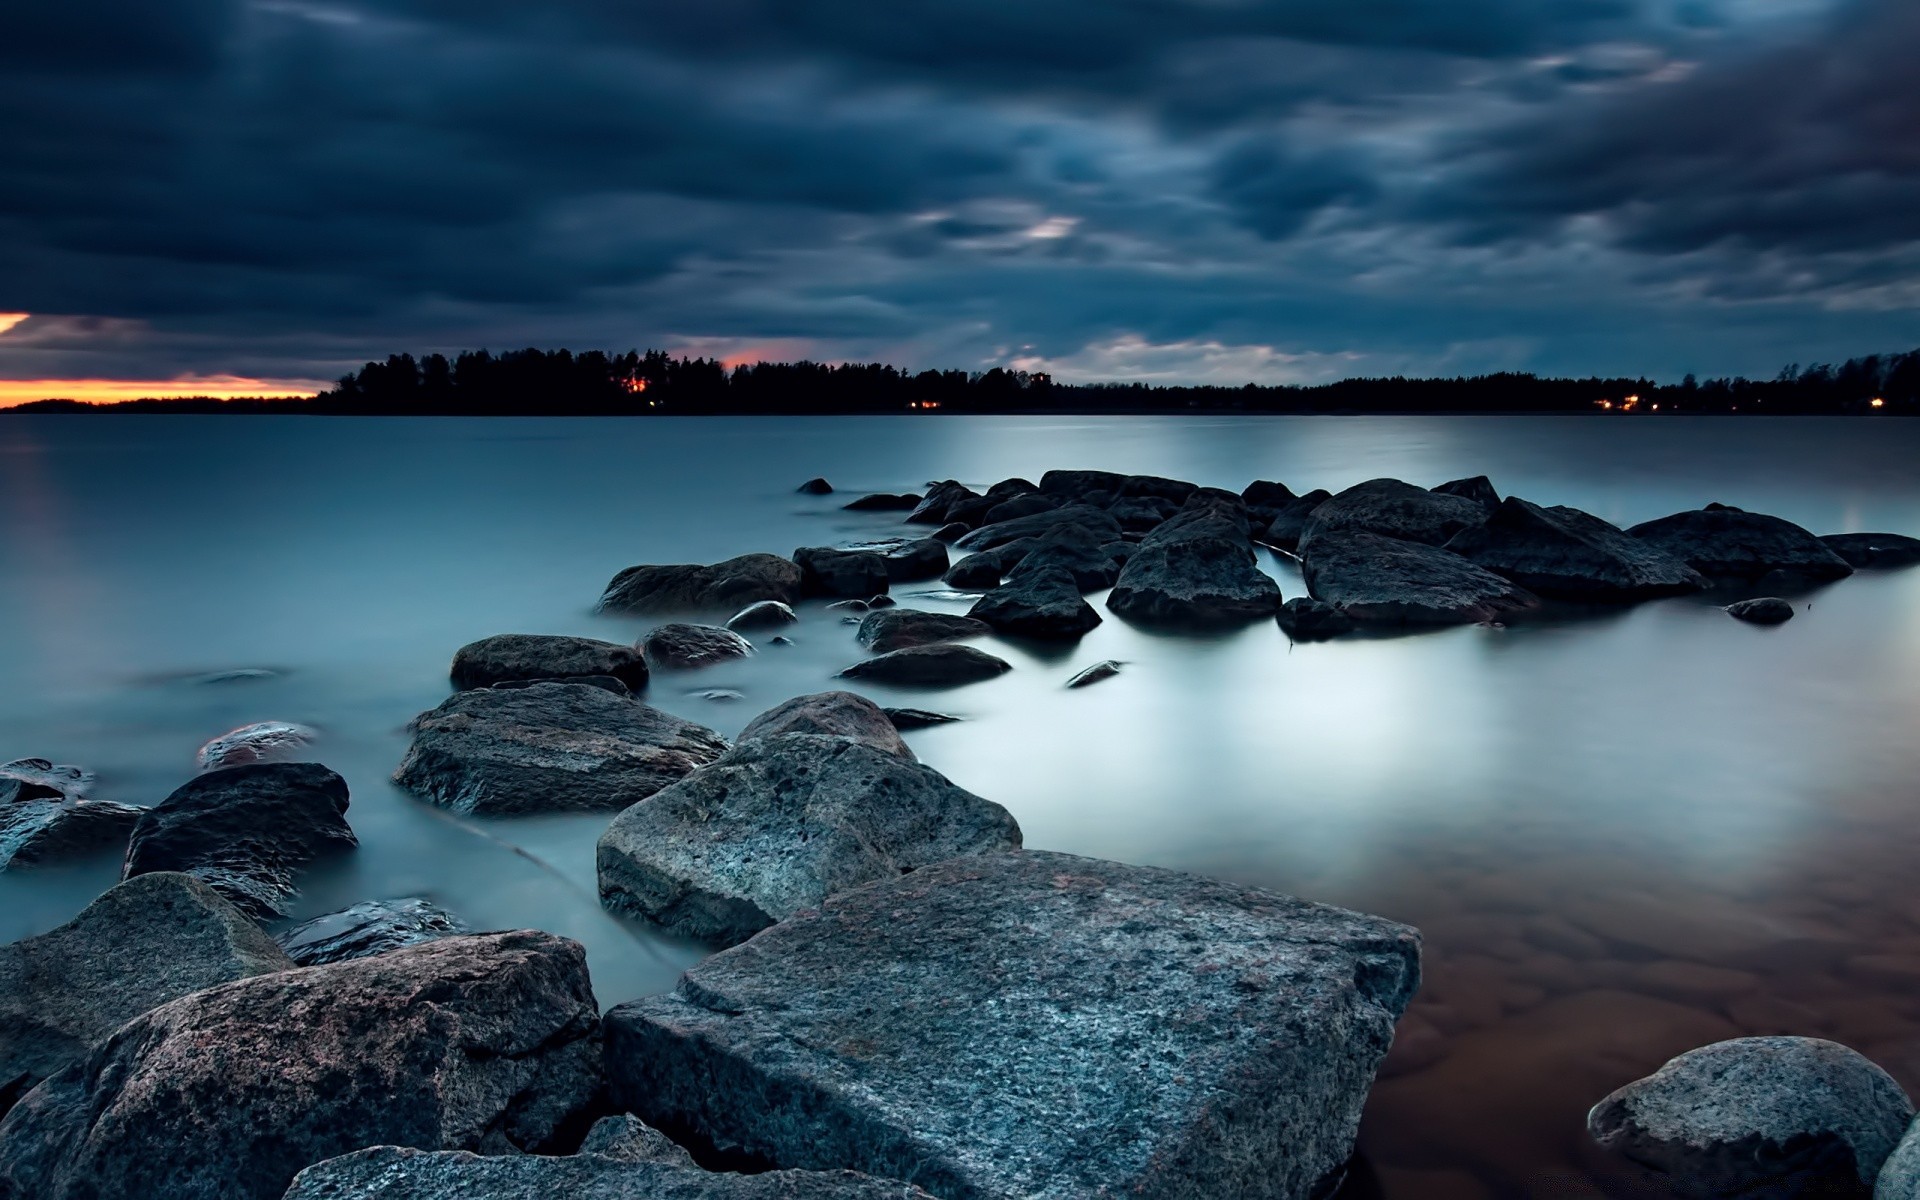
left=123, top=762, right=359, bottom=918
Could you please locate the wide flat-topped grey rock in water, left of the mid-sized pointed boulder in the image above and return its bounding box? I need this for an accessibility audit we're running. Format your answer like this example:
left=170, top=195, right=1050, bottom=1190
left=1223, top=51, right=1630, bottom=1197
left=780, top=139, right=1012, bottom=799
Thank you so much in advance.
left=394, top=684, right=726, bottom=816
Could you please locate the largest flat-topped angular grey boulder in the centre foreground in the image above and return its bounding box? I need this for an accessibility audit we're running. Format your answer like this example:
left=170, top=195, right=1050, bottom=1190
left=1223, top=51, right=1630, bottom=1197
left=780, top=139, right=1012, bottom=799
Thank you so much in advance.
left=607, top=851, right=1419, bottom=1200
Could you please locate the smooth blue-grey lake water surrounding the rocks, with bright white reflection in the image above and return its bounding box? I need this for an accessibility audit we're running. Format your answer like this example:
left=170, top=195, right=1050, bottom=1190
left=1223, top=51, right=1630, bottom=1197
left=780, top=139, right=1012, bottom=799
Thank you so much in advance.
left=0, top=417, right=1920, bottom=1200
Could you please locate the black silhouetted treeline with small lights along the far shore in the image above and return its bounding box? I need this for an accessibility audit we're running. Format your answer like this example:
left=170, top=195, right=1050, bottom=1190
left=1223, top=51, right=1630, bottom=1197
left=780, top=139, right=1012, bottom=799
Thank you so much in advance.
left=13, top=341, right=1920, bottom=417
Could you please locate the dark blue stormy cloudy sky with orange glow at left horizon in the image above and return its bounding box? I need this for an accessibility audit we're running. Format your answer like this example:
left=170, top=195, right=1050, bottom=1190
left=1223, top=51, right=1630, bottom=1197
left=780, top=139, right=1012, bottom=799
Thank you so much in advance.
left=0, top=0, right=1920, bottom=399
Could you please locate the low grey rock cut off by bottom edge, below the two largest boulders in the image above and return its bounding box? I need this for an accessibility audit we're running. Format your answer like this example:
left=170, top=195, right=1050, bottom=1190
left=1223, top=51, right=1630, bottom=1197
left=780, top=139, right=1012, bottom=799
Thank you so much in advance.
left=286, top=1144, right=931, bottom=1200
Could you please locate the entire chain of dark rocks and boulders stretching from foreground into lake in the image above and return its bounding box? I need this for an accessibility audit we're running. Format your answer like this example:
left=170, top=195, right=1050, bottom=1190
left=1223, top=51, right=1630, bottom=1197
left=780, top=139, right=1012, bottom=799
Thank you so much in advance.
left=0, top=470, right=1920, bottom=1200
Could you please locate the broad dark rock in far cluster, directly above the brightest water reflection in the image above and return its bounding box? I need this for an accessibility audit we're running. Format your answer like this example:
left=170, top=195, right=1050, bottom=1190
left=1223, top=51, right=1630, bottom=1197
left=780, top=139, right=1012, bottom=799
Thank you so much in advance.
left=1302, top=530, right=1540, bottom=624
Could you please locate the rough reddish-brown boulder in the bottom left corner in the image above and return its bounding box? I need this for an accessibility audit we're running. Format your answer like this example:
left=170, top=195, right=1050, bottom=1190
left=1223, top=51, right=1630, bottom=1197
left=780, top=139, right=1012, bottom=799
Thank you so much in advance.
left=0, top=931, right=601, bottom=1200
